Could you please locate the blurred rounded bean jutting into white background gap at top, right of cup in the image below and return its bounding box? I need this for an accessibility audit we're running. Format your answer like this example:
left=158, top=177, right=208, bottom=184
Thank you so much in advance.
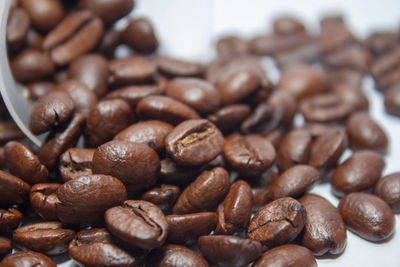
left=122, top=18, right=158, bottom=54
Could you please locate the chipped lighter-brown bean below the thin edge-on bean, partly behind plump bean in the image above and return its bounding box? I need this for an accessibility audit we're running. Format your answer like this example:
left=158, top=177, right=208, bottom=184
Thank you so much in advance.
left=58, top=147, right=96, bottom=182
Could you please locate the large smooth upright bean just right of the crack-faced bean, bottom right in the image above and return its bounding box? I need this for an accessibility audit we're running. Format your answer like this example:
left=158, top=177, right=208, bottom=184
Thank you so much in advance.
left=299, top=194, right=347, bottom=256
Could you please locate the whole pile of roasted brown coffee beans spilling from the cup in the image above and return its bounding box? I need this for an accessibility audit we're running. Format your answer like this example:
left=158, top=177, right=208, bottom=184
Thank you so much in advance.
left=0, top=0, right=400, bottom=266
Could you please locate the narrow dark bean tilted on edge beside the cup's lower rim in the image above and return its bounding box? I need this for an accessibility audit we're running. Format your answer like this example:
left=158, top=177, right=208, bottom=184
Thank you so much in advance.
left=38, top=113, right=85, bottom=169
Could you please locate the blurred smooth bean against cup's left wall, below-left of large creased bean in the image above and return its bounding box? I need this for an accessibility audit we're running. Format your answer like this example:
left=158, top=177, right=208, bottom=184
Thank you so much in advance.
left=10, top=48, right=55, bottom=83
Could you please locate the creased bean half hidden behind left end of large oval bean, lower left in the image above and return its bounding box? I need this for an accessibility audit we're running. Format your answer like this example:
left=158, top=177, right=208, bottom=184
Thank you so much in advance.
left=29, top=183, right=61, bottom=221
